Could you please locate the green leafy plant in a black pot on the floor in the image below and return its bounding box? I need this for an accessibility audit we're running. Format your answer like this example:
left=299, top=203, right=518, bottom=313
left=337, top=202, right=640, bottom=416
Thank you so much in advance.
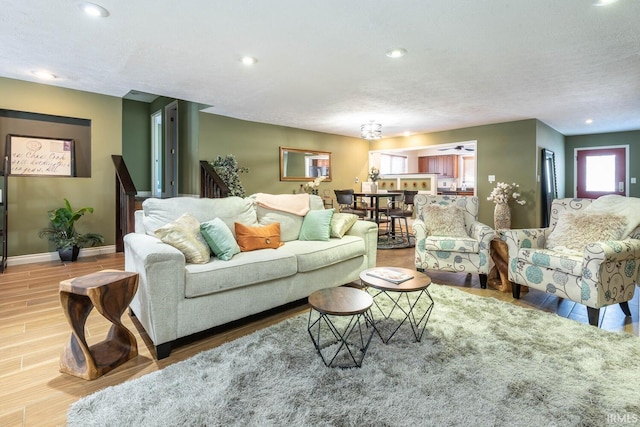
left=38, top=199, right=104, bottom=261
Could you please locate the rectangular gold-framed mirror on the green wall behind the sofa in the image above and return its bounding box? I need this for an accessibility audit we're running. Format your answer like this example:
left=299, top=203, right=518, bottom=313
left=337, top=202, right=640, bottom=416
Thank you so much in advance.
left=280, top=147, right=331, bottom=181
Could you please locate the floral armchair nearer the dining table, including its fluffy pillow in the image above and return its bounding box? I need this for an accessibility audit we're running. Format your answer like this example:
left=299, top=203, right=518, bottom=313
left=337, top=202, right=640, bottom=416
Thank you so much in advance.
left=413, top=194, right=495, bottom=288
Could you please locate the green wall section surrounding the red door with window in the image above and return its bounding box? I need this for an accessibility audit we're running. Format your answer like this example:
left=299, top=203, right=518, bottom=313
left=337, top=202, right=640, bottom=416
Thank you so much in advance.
left=565, top=130, right=640, bottom=197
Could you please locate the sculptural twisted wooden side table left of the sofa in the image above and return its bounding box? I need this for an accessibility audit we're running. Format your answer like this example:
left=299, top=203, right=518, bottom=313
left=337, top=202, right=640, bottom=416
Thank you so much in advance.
left=60, top=270, right=138, bottom=380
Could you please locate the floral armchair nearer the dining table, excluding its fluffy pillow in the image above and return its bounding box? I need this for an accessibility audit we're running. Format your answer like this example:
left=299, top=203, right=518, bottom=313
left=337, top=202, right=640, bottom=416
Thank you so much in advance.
left=413, top=194, right=495, bottom=288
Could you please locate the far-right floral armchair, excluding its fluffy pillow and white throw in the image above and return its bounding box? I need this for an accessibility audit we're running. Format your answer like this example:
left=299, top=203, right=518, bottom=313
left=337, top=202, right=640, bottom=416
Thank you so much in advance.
left=503, top=198, right=640, bottom=326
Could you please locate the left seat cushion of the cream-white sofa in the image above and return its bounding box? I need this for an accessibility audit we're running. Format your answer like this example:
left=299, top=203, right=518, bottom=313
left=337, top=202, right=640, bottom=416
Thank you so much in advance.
left=185, top=248, right=297, bottom=304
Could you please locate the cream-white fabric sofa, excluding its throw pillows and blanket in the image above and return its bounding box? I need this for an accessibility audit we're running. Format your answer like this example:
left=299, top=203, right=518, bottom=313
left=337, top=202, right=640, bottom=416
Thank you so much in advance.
left=124, top=195, right=378, bottom=359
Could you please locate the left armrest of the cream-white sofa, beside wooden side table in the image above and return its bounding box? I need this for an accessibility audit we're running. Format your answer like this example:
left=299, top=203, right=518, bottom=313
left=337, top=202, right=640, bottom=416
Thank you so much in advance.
left=124, top=233, right=186, bottom=345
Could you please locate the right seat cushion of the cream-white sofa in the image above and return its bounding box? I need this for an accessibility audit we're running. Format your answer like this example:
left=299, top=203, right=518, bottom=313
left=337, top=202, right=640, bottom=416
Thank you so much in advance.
left=281, top=236, right=365, bottom=273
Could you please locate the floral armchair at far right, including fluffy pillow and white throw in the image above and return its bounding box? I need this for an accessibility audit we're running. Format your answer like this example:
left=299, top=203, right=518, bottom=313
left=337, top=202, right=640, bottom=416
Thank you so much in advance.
left=503, top=195, right=640, bottom=326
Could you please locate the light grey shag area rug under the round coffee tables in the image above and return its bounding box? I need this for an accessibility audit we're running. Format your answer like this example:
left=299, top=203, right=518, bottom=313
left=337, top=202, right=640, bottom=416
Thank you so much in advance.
left=68, top=284, right=640, bottom=427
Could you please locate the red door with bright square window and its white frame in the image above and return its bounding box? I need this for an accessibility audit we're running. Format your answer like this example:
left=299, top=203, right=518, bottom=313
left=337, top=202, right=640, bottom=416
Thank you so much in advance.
left=575, top=146, right=629, bottom=199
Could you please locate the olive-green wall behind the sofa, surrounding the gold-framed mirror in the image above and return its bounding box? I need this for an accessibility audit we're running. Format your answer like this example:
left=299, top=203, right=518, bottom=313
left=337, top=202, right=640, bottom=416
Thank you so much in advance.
left=198, top=113, right=369, bottom=197
